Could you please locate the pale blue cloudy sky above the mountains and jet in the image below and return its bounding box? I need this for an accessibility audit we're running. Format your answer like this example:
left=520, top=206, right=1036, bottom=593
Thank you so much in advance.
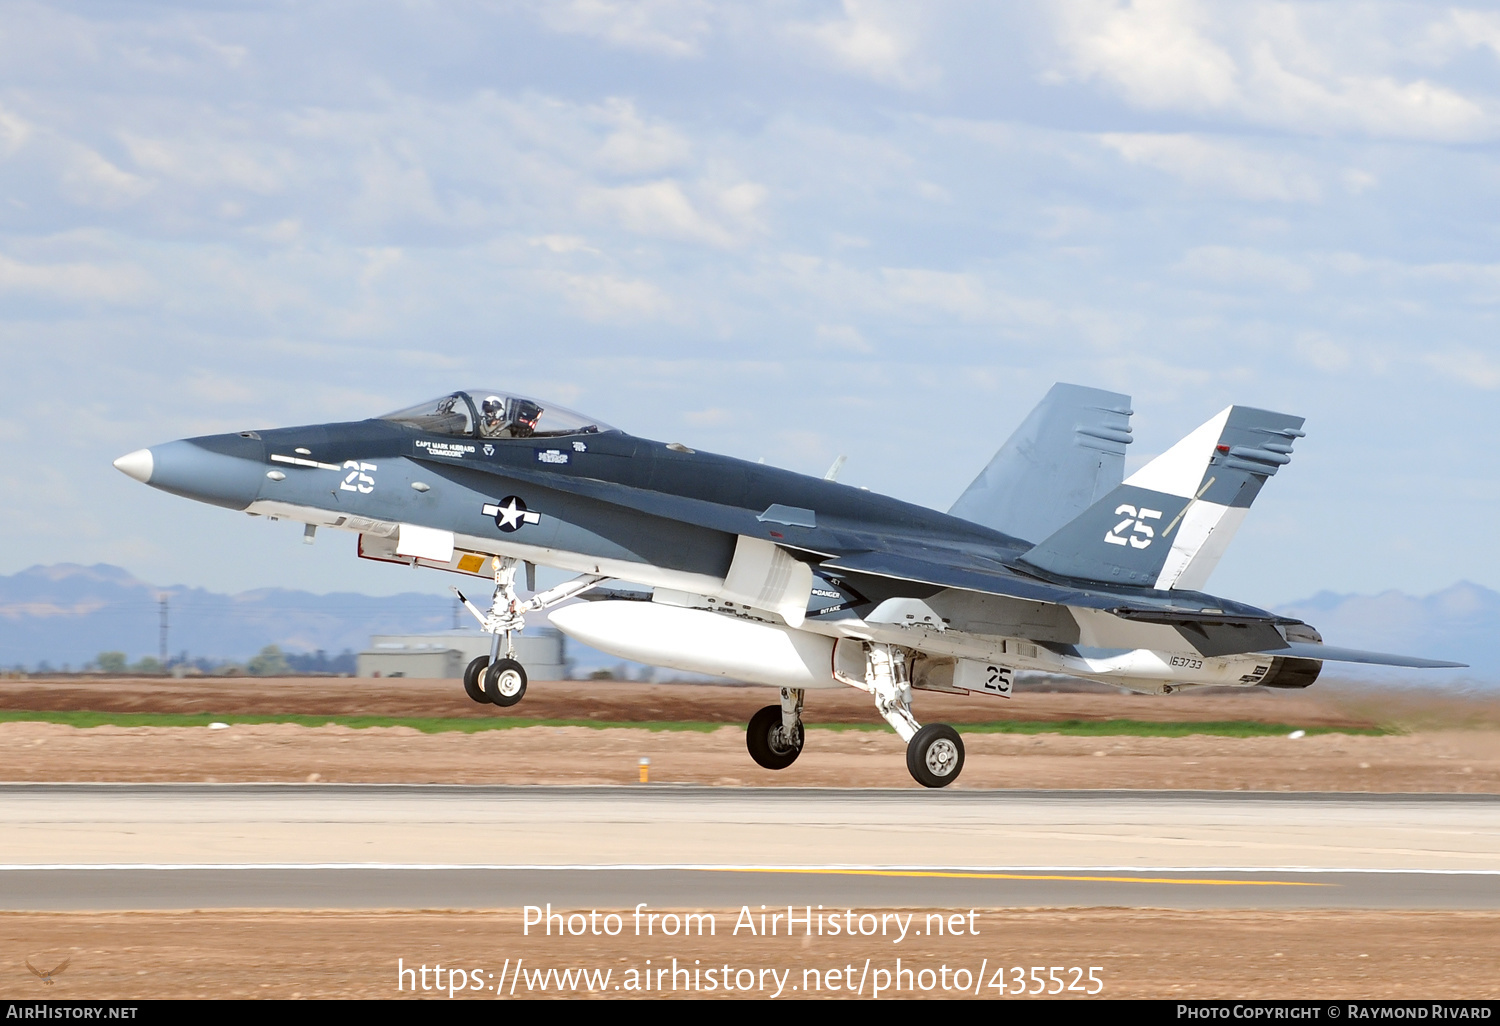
left=0, top=0, right=1500, bottom=605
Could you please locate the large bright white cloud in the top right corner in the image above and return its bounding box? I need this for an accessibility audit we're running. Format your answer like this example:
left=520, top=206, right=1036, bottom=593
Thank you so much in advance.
left=1052, top=0, right=1500, bottom=141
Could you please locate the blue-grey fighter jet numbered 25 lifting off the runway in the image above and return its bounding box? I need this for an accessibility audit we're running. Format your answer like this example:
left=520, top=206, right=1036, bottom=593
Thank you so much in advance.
left=114, top=384, right=1461, bottom=788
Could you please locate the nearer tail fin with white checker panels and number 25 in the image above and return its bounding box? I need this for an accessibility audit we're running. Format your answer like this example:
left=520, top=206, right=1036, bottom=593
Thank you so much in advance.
left=1022, top=407, right=1304, bottom=591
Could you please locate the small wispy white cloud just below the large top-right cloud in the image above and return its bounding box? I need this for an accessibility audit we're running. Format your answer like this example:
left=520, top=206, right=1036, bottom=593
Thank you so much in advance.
left=1100, top=132, right=1322, bottom=203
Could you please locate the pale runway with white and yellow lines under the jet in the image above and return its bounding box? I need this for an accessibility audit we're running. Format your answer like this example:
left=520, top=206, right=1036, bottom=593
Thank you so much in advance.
left=0, top=785, right=1500, bottom=911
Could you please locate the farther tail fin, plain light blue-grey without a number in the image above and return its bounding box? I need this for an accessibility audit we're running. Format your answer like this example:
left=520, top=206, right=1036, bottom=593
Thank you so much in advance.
left=948, top=383, right=1131, bottom=542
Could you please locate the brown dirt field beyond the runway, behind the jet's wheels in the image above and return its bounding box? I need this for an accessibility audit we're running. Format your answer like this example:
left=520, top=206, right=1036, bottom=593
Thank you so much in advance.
left=0, top=678, right=1500, bottom=794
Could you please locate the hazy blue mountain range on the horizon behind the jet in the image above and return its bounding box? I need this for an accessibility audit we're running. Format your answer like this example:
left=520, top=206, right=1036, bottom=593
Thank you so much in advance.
left=0, top=563, right=1500, bottom=683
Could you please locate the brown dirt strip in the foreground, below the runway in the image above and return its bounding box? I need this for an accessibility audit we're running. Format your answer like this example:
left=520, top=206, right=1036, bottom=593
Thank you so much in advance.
left=0, top=909, right=1500, bottom=1001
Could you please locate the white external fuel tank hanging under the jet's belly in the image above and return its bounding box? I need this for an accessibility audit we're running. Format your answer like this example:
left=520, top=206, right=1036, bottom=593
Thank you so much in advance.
left=548, top=600, right=845, bottom=689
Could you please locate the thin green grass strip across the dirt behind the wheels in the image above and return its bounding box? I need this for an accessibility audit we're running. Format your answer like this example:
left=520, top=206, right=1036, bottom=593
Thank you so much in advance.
left=0, top=710, right=1380, bottom=738
